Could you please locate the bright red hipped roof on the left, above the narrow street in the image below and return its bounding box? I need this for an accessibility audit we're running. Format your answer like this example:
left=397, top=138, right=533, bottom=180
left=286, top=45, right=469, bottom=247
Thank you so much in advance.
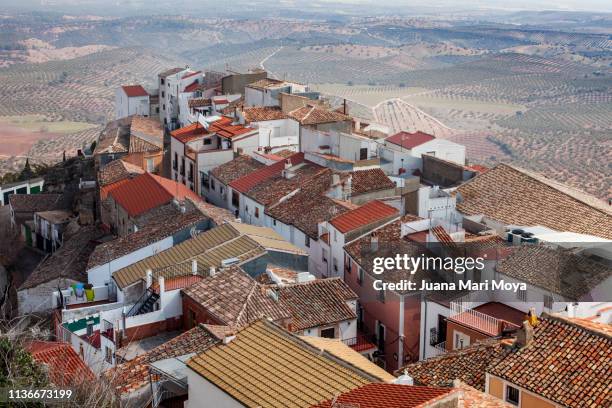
left=109, top=173, right=200, bottom=217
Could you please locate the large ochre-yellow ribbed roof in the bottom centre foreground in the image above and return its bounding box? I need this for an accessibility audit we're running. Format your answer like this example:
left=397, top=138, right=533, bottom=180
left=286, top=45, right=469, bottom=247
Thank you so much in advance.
left=187, top=320, right=372, bottom=408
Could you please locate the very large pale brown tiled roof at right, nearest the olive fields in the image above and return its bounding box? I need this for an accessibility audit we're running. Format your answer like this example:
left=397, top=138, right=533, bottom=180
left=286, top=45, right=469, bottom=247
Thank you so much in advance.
left=456, top=164, right=612, bottom=239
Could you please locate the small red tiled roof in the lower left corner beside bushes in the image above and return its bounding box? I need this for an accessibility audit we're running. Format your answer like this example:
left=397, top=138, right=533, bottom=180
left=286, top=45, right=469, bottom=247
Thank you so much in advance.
left=26, top=341, right=94, bottom=386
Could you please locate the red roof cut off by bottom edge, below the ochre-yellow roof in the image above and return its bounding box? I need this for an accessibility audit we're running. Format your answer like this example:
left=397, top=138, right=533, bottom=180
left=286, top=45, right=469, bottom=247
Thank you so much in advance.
left=311, top=383, right=455, bottom=408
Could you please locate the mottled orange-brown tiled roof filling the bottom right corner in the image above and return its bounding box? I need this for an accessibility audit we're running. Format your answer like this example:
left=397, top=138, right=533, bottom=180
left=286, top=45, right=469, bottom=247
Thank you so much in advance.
left=487, top=316, right=612, bottom=408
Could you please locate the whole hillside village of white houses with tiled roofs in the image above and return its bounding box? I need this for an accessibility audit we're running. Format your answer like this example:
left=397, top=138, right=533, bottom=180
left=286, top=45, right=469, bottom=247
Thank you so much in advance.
left=0, top=67, right=612, bottom=408
